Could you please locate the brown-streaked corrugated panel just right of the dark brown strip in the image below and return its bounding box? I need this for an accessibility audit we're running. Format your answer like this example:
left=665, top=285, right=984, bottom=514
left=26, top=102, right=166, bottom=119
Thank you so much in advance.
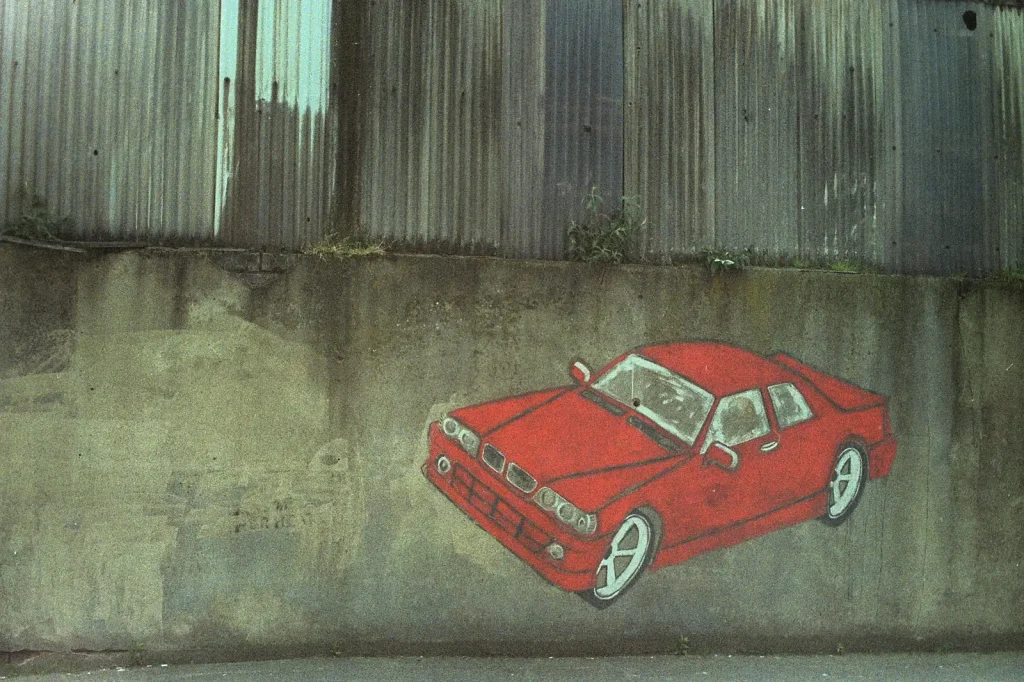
left=360, top=0, right=502, bottom=251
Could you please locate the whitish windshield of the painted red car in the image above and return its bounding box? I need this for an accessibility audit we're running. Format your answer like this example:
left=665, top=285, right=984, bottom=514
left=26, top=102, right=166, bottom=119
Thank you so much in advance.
left=593, top=355, right=715, bottom=445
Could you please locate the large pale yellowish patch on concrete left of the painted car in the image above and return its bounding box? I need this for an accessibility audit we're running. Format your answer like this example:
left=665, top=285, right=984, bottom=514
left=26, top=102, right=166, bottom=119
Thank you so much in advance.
left=0, top=249, right=365, bottom=648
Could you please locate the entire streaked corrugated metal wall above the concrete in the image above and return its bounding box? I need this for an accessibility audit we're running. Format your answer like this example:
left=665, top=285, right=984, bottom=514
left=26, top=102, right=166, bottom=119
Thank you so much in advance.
left=0, top=0, right=1024, bottom=273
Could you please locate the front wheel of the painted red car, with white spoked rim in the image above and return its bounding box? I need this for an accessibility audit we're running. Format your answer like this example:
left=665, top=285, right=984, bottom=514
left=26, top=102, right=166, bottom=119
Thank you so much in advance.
left=577, top=510, right=662, bottom=608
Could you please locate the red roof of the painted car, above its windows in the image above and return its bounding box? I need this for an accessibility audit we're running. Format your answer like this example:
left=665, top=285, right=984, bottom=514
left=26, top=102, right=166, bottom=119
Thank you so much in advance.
left=635, top=343, right=794, bottom=397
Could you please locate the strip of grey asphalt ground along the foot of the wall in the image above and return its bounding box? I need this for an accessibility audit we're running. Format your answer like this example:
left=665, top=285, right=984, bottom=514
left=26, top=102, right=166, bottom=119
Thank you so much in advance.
left=4, top=652, right=1024, bottom=682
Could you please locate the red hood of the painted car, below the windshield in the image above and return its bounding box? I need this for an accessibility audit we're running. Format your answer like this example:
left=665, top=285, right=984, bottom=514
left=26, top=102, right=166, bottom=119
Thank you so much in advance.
left=473, top=390, right=689, bottom=483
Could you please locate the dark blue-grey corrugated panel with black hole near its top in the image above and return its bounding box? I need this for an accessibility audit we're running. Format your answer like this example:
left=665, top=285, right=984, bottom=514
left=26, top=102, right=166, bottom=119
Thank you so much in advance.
left=897, top=0, right=996, bottom=273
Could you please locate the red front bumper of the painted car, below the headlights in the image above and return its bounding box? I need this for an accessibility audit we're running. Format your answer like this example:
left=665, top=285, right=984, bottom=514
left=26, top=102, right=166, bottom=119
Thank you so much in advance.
left=423, top=423, right=608, bottom=592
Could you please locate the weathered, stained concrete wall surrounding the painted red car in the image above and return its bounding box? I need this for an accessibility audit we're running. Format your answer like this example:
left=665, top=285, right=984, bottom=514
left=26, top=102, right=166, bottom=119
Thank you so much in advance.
left=0, top=246, right=1024, bottom=658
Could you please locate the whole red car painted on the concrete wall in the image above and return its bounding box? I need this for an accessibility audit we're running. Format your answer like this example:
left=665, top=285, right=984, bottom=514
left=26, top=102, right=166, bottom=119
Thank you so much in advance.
left=423, top=343, right=896, bottom=607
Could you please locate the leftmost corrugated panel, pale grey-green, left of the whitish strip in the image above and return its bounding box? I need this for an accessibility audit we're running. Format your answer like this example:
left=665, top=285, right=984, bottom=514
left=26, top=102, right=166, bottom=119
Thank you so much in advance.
left=0, top=0, right=218, bottom=241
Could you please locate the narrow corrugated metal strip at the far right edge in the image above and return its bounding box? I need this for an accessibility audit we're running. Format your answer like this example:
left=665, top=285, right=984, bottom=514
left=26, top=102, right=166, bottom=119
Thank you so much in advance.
left=987, top=9, right=1024, bottom=271
